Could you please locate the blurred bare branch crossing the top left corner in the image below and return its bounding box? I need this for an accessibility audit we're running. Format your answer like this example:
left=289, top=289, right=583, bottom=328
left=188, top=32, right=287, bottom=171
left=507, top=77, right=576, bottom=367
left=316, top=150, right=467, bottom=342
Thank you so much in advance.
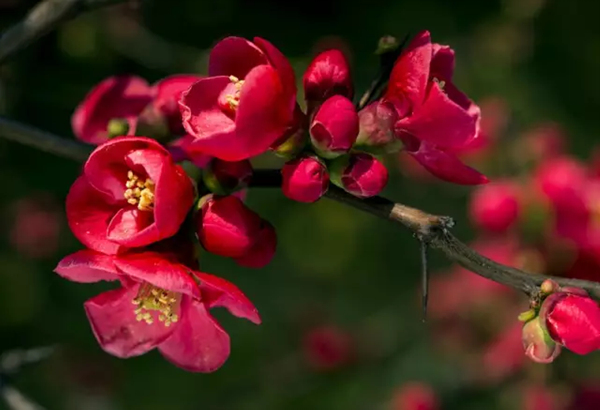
left=0, top=0, right=125, bottom=64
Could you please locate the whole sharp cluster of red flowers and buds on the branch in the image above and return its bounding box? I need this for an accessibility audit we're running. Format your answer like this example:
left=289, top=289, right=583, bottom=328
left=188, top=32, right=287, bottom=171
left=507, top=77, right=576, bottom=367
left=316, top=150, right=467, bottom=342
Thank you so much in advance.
left=56, top=32, right=487, bottom=372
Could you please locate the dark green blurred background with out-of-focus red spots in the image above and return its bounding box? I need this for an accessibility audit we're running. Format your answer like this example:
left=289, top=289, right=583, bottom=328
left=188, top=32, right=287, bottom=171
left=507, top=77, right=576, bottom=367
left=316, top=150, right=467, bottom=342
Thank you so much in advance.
left=0, top=0, right=600, bottom=410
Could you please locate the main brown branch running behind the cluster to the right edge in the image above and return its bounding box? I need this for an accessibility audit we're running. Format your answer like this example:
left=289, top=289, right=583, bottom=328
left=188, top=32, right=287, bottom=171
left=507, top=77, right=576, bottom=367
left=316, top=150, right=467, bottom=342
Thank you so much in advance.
left=0, top=117, right=600, bottom=300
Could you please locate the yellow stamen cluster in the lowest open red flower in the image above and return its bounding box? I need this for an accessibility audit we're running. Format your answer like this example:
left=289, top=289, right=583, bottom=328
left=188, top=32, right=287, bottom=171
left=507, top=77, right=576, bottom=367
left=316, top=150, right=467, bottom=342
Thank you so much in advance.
left=131, top=283, right=181, bottom=327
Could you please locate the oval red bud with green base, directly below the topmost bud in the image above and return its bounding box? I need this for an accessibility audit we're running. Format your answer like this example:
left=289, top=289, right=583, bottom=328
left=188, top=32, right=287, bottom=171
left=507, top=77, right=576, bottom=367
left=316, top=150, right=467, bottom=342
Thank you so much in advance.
left=310, top=95, right=358, bottom=158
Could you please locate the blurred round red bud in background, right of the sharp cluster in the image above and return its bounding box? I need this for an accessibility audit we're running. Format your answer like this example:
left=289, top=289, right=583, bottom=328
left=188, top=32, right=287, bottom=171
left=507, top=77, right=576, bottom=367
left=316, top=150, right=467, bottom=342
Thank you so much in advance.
left=470, top=181, right=521, bottom=233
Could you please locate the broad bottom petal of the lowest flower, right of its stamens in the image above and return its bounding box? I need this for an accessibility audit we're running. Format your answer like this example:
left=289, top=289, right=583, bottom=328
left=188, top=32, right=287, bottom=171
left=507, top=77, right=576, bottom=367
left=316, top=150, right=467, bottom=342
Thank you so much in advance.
left=158, top=298, right=230, bottom=373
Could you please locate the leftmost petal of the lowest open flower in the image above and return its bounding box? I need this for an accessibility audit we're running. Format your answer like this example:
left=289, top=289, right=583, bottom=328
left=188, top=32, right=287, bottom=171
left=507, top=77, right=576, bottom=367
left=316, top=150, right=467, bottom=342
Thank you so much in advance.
left=54, top=249, right=118, bottom=283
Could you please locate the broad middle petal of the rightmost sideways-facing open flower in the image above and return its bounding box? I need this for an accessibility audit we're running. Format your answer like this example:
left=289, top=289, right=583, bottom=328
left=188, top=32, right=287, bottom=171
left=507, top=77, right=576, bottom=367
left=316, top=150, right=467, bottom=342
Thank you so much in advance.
left=395, top=83, right=479, bottom=148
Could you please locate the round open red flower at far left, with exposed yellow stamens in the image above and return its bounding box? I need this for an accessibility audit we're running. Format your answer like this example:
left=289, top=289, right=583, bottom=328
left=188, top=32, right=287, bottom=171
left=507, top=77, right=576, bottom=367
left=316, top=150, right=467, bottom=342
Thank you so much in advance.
left=67, top=137, right=194, bottom=254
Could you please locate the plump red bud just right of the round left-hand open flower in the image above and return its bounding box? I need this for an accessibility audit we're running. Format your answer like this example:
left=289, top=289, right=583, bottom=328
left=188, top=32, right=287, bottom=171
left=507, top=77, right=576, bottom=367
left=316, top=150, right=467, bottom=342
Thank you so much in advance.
left=196, top=195, right=261, bottom=258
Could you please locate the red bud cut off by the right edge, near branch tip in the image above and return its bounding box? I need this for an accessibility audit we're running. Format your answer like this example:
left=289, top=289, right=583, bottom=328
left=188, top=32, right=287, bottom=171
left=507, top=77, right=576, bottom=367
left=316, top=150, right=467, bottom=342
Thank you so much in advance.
left=540, top=291, right=600, bottom=354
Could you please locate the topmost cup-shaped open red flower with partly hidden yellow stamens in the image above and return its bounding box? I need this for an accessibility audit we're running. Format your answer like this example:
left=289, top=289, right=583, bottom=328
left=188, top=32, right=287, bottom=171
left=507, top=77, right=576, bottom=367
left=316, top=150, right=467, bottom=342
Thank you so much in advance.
left=180, top=37, right=296, bottom=161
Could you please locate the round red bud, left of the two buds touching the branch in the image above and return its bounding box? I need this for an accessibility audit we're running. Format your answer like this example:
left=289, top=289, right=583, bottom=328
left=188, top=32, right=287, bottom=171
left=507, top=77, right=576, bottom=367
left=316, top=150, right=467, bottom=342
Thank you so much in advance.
left=281, top=157, right=329, bottom=202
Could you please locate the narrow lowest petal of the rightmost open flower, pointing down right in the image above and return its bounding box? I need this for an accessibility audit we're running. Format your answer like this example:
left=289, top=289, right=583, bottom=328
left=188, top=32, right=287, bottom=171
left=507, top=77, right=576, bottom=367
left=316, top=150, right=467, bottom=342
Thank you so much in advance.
left=409, top=142, right=488, bottom=185
